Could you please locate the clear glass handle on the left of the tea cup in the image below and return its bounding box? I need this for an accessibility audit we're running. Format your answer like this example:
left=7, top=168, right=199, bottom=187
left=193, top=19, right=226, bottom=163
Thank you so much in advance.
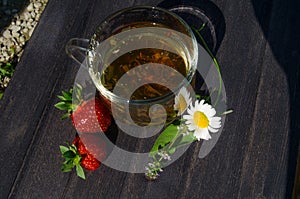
left=66, top=38, right=89, bottom=65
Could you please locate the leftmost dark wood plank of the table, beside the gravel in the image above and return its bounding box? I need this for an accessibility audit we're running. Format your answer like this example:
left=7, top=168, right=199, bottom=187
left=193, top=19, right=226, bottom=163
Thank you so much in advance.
left=0, top=2, right=86, bottom=197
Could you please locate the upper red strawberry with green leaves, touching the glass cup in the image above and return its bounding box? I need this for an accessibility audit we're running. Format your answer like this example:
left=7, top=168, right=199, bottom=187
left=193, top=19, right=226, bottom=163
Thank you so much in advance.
left=55, top=84, right=111, bottom=133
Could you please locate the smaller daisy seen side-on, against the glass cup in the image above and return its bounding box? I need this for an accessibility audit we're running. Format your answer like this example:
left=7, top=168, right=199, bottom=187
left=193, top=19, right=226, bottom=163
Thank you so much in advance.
left=174, top=87, right=192, bottom=116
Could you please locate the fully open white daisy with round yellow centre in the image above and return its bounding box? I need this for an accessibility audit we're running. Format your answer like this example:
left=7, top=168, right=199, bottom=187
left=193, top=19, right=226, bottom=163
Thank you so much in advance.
left=183, top=100, right=221, bottom=140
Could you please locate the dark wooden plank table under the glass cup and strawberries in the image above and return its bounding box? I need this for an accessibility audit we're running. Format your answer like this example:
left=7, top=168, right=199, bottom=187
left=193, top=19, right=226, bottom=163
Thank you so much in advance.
left=0, top=0, right=300, bottom=199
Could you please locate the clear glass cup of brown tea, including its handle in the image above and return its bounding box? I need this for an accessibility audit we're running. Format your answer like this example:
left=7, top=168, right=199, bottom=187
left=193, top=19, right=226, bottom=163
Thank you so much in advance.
left=66, top=6, right=198, bottom=131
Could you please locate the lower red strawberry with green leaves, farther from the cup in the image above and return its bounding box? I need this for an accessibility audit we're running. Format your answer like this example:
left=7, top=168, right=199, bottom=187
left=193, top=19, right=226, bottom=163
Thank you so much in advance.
left=60, top=134, right=106, bottom=179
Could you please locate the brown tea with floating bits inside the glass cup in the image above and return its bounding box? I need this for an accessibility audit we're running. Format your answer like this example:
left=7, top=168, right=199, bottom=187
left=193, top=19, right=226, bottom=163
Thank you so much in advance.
left=101, top=48, right=187, bottom=100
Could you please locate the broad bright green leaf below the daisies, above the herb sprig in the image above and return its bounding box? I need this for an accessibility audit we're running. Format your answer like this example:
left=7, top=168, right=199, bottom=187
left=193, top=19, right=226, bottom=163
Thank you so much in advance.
left=150, top=124, right=178, bottom=156
